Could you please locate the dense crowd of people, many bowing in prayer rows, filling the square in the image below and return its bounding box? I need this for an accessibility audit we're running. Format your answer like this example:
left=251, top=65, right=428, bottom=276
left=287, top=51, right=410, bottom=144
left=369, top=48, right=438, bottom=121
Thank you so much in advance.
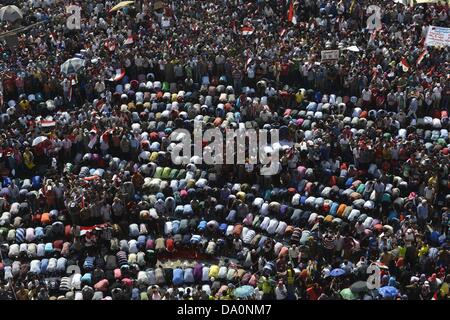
left=0, top=0, right=450, bottom=300
